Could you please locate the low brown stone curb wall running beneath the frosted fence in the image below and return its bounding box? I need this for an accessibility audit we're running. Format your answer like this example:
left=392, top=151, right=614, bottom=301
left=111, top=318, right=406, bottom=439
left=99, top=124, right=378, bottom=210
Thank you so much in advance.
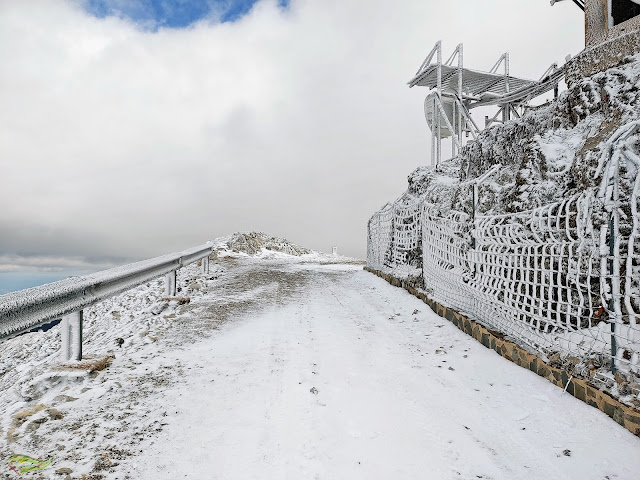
left=364, top=267, right=640, bottom=437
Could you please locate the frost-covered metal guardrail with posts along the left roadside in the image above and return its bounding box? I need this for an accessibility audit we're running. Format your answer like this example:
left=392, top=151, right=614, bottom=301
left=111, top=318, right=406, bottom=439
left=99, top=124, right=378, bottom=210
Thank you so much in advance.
left=0, top=242, right=214, bottom=360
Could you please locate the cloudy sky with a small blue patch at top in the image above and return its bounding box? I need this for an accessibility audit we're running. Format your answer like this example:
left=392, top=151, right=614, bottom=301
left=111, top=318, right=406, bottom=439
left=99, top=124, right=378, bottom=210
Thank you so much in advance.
left=0, top=0, right=584, bottom=272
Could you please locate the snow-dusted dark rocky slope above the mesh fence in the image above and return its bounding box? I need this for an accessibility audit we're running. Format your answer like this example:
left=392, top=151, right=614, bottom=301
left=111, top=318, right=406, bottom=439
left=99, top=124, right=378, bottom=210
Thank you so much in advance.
left=405, top=51, right=640, bottom=214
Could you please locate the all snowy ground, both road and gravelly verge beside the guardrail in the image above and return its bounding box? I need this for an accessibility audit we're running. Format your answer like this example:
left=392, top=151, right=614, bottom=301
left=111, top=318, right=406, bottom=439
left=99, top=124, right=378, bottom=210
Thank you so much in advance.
left=0, top=251, right=640, bottom=480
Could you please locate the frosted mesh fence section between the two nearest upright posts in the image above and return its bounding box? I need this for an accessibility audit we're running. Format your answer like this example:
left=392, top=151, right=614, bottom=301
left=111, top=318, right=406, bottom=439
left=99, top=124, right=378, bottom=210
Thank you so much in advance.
left=469, top=195, right=608, bottom=356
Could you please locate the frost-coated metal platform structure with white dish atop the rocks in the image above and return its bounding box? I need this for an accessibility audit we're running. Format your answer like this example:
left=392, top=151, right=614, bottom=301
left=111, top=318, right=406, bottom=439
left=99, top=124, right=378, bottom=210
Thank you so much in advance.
left=408, top=42, right=564, bottom=166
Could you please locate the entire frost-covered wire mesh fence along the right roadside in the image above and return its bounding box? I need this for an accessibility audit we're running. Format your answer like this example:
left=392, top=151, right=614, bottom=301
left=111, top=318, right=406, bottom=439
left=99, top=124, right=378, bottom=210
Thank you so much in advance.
left=367, top=125, right=640, bottom=374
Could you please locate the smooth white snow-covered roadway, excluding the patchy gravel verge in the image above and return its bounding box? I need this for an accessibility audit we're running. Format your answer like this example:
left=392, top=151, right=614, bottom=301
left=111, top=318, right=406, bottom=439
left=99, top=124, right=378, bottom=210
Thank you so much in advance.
left=121, top=264, right=640, bottom=480
